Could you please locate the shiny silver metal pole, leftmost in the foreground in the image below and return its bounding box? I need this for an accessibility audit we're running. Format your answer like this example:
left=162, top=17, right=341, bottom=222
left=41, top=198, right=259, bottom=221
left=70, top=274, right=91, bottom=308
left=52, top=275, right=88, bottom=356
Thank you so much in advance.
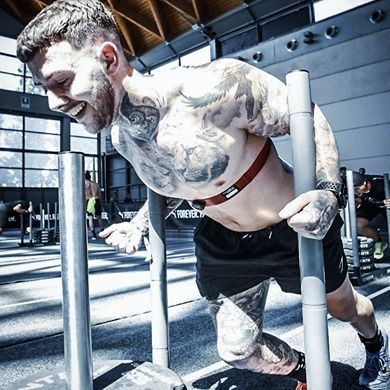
left=58, top=152, right=93, bottom=390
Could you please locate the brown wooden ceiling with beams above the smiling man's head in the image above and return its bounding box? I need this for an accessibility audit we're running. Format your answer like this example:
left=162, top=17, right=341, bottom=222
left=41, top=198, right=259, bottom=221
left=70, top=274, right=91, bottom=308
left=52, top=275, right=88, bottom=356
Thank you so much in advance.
left=0, top=0, right=253, bottom=57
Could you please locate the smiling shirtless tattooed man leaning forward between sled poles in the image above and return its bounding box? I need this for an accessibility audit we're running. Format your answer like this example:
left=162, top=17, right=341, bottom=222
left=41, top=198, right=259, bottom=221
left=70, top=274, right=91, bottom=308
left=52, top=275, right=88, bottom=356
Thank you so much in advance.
left=17, top=0, right=390, bottom=389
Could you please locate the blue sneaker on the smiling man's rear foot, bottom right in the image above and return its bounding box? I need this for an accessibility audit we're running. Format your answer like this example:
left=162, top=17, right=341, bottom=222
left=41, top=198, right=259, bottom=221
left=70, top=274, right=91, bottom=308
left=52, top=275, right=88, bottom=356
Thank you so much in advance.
left=359, top=330, right=390, bottom=390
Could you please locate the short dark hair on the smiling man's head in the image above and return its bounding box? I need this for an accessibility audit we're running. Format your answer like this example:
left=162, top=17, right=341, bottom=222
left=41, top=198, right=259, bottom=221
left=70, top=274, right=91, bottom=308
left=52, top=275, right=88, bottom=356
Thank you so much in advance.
left=16, top=0, right=120, bottom=62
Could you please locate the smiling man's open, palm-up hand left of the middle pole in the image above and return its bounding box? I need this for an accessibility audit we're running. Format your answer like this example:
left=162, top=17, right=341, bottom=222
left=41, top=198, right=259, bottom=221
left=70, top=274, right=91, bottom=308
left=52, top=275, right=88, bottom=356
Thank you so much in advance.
left=99, top=222, right=143, bottom=255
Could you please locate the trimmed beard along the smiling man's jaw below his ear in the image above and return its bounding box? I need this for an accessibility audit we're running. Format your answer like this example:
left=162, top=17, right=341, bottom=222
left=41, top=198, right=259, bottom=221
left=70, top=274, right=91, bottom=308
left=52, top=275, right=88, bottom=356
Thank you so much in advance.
left=84, top=71, right=115, bottom=134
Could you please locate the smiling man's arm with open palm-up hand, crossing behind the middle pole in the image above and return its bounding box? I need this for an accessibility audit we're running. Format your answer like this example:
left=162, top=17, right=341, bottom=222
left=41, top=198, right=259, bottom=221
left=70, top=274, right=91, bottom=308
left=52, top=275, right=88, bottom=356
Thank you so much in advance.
left=99, top=198, right=183, bottom=254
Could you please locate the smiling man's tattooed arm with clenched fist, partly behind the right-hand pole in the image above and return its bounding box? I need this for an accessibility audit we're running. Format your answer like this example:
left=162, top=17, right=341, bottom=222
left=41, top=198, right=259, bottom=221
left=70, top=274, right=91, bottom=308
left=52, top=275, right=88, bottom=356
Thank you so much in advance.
left=229, top=60, right=340, bottom=239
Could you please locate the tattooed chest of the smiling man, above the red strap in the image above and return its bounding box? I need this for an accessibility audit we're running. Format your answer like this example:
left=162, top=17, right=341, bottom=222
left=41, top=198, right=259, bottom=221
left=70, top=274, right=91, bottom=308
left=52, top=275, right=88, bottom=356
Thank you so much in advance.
left=112, top=115, right=241, bottom=198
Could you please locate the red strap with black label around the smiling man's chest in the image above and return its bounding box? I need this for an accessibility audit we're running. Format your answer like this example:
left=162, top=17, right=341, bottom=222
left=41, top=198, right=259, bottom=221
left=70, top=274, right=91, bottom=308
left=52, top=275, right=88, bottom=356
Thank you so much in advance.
left=190, top=138, right=271, bottom=210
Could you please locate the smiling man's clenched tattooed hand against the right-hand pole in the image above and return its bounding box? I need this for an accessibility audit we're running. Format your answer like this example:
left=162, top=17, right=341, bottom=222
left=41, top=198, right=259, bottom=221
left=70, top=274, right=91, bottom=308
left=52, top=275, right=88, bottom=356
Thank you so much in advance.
left=279, top=190, right=338, bottom=240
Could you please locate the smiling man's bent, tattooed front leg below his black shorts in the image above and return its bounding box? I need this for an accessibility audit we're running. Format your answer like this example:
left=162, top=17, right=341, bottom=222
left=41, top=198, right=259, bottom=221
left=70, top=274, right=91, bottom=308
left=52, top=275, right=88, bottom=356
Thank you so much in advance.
left=209, top=281, right=298, bottom=375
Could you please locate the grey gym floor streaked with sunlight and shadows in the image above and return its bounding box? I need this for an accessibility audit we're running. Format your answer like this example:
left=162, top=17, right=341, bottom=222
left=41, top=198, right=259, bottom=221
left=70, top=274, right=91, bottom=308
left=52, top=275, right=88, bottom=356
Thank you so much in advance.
left=0, top=232, right=390, bottom=390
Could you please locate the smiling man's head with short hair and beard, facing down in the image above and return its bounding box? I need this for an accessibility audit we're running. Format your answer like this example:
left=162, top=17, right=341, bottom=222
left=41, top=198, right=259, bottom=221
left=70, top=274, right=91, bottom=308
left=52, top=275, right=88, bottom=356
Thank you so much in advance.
left=17, top=0, right=124, bottom=133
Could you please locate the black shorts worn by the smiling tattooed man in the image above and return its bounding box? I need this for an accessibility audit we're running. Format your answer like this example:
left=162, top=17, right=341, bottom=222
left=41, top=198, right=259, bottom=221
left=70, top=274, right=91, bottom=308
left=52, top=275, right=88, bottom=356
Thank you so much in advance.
left=194, top=215, right=348, bottom=299
